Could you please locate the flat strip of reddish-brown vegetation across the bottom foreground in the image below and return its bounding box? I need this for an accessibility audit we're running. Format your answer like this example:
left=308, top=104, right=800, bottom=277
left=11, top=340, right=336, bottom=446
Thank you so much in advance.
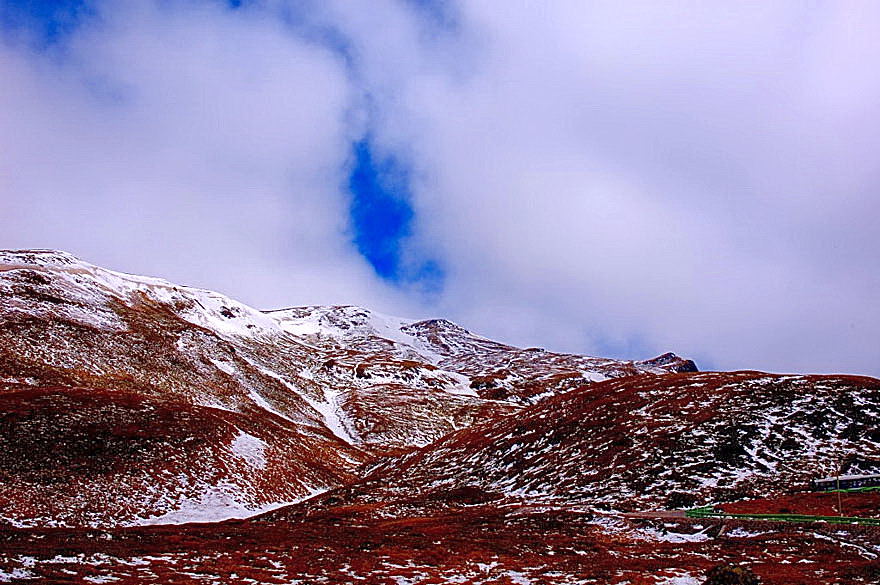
left=0, top=504, right=878, bottom=585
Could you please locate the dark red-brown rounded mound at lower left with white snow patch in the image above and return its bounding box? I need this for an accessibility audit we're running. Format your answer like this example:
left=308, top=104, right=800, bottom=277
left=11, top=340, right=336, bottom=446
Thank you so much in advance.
left=0, top=386, right=353, bottom=526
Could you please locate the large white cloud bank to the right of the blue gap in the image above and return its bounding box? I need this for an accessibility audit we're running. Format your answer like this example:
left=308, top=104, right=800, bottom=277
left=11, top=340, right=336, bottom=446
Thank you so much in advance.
left=332, top=2, right=880, bottom=373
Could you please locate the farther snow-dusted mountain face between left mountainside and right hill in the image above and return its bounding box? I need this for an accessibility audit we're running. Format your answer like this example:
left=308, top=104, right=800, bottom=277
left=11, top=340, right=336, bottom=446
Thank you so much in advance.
left=267, top=306, right=695, bottom=449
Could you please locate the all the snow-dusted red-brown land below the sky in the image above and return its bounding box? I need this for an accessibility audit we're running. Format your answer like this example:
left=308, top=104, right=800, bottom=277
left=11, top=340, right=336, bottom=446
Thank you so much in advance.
left=0, top=251, right=880, bottom=585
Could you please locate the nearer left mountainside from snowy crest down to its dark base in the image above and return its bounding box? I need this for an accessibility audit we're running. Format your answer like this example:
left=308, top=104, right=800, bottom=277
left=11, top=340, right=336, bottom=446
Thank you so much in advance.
left=0, top=252, right=371, bottom=526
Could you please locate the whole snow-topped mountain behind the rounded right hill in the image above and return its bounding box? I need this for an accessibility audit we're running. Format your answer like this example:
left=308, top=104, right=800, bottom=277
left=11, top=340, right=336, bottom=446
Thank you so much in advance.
left=0, top=250, right=694, bottom=526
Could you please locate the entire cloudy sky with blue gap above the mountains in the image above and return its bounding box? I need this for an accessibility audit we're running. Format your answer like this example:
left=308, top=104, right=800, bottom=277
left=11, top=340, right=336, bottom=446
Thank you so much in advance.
left=0, top=0, right=880, bottom=376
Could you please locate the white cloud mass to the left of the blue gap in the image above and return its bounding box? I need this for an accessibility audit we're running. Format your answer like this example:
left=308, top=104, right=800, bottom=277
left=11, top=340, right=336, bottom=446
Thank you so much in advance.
left=0, top=2, right=410, bottom=306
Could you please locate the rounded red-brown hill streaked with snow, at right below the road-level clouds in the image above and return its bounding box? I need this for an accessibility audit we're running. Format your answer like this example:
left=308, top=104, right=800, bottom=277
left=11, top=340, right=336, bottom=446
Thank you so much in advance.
left=340, top=372, right=880, bottom=509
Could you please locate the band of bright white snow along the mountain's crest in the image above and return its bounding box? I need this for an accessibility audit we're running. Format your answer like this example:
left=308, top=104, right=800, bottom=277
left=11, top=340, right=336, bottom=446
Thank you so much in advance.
left=0, top=250, right=696, bottom=380
